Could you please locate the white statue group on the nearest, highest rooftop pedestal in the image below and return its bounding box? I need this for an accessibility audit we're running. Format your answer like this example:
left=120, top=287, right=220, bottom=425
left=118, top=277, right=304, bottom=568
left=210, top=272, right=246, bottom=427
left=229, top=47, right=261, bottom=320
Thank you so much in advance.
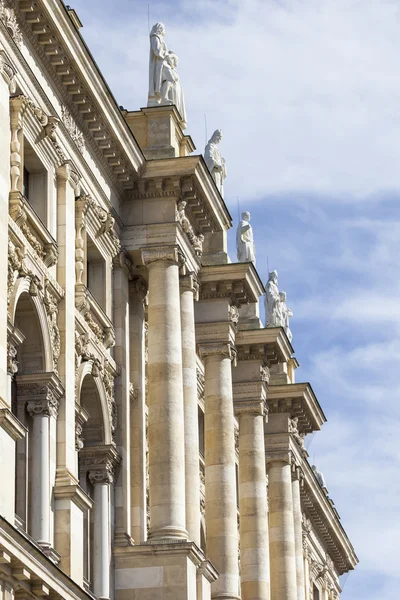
left=147, top=23, right=186, bottom=127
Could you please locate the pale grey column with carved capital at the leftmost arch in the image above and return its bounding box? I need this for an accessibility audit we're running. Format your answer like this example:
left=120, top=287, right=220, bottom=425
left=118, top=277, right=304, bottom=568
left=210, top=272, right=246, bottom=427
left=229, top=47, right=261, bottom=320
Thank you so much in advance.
left=23, top=374, right=60, bottom=550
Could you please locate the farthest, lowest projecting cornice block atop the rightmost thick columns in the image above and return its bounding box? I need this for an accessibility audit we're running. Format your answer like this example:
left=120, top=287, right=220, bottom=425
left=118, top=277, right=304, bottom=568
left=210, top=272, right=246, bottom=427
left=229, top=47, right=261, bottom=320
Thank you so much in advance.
left=268, top=383, right=326, bottom=434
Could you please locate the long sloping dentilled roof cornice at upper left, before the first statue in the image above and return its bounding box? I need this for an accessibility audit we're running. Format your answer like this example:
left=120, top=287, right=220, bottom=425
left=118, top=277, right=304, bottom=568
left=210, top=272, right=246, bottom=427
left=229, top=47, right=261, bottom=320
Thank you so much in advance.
left=12, top=0, right=144, bottom=188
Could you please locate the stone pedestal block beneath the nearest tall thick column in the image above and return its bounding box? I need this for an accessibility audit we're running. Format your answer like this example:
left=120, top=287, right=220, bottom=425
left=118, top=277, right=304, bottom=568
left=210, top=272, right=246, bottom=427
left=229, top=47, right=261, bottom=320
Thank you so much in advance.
left=114, top=541, right=217, bottom=600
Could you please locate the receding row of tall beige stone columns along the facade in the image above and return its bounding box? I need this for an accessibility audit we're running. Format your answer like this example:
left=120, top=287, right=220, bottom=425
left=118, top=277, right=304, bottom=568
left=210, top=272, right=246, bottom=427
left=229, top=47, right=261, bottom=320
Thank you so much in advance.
left=142, top=247, right=310, bottom=600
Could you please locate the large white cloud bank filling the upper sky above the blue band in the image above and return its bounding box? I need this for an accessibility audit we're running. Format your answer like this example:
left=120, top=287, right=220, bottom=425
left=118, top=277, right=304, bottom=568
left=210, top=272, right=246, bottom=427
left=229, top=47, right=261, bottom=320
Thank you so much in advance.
left=75, top=0, right=400, bottom=200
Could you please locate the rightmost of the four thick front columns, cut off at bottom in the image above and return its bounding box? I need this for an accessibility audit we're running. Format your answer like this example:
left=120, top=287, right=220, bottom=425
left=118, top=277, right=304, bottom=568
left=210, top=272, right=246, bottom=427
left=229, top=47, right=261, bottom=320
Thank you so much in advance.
left=267, top=452, right=297, bottom=600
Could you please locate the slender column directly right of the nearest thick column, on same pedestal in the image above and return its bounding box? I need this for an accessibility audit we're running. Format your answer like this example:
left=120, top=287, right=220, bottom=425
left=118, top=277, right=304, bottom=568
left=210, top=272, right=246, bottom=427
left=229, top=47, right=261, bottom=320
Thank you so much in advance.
left=181, top=273, right=200, bottom=547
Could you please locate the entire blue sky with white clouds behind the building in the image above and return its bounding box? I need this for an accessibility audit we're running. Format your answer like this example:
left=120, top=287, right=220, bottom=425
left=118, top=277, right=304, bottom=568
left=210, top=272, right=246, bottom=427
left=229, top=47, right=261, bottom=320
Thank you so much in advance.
left=73, top=0, right=400, bottom=600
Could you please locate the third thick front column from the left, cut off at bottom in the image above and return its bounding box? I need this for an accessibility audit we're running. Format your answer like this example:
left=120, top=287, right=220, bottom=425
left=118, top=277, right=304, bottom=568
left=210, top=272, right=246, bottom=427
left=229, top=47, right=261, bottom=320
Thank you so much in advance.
left=235, top=400, right=270, bottom=600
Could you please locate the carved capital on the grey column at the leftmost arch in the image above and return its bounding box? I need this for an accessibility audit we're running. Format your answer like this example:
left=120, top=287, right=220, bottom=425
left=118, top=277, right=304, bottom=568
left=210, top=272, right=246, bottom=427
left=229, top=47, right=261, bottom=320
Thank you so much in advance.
left=16, top=372, right=64, bottom=418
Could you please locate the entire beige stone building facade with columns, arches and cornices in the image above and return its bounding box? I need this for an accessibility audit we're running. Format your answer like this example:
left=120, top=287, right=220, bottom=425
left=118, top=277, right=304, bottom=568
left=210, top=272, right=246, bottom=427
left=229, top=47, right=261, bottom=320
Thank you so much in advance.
left=0, top=0, right=357, bottom=600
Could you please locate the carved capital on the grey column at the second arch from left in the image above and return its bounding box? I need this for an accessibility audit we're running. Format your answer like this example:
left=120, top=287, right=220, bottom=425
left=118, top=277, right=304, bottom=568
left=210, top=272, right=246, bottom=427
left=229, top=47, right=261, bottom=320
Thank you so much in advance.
left=79, top=445, right=121, bottom=485
